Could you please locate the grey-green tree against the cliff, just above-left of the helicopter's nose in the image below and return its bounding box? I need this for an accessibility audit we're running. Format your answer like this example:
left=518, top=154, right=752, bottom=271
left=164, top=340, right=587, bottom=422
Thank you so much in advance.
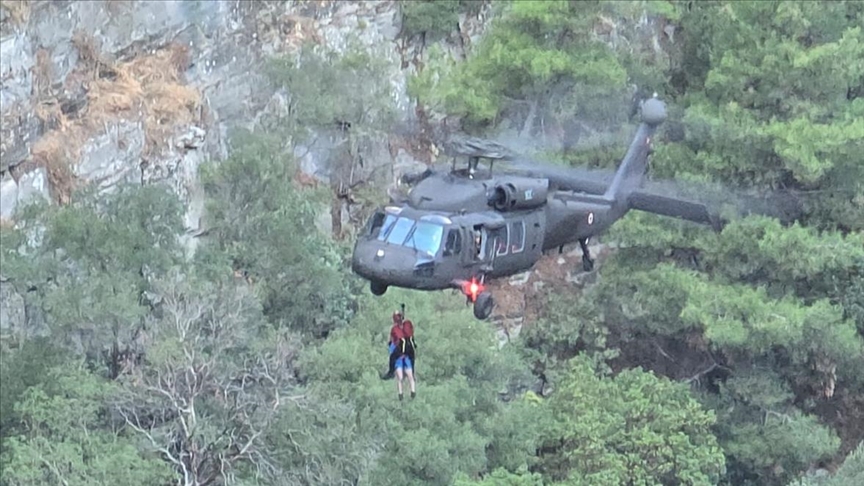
left=265, top=39, right=397, bottom=238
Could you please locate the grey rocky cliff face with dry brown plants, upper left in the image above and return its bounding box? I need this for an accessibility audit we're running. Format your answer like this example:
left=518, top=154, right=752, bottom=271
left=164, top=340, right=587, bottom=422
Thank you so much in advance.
left=0, top=0, right=668, bottom=334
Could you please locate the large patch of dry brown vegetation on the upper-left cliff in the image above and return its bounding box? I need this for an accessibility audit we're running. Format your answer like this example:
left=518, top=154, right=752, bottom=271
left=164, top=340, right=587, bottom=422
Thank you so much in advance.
left=32, top=32, right=200, bottom=204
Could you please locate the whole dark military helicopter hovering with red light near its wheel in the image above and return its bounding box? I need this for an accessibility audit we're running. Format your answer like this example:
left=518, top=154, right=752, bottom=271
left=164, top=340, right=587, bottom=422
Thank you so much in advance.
left=351, top=94, right=721, bottom=320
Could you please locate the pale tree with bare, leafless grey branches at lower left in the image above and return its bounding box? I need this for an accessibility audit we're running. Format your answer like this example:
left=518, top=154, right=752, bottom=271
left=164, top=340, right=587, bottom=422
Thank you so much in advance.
left=113, top=272, right=303, bottom=486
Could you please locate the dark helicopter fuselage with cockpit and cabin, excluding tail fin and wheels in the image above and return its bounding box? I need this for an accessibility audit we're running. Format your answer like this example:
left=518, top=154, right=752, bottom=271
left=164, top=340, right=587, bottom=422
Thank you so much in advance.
left=352, top=174, right=627, bottom=290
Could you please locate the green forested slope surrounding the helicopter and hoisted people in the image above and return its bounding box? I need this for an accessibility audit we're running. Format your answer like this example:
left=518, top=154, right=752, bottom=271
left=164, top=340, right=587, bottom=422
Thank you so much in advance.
left=0, top=1, right=864, bottom=486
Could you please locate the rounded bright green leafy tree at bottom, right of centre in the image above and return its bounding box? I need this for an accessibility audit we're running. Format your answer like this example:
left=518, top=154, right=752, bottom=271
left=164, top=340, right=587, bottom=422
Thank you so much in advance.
left=542, top=357, right=724, bottom=484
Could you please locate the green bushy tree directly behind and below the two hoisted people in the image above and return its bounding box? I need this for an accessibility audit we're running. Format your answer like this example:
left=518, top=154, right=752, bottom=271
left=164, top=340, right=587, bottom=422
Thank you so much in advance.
left=300, top=289, right=539, bottom=484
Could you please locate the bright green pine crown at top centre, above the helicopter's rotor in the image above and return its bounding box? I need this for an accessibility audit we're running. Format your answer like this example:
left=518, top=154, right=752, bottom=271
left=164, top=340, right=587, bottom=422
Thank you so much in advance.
left=412, top=1, right=627, bottom=128
